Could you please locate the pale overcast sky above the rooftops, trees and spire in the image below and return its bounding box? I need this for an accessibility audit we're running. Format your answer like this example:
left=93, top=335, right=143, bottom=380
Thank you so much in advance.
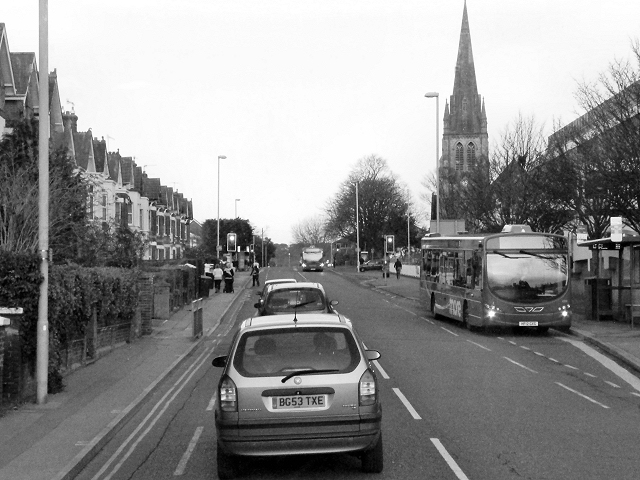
left=0, top=0, right=640, bottom=243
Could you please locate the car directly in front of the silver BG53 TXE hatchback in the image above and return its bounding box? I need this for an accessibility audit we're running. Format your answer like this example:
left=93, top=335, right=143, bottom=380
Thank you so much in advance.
left=254, top=282, right=338, bottom=315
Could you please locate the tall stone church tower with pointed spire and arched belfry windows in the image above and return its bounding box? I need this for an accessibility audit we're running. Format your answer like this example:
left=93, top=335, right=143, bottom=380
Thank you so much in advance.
left=438, top=0, right=489, bottom=177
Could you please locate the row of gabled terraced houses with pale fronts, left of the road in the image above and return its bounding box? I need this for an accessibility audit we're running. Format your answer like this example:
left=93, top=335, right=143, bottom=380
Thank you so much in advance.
left=0, top=23, right=193, bottom=260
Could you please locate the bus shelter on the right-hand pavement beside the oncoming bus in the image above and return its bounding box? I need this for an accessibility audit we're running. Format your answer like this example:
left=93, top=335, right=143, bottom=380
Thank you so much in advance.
left=577, top=232, right=640, bottom=328
